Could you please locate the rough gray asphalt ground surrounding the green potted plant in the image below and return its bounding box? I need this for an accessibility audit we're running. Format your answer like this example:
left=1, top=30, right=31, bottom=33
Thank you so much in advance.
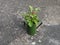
left=0, top=0, right=60, bottom=45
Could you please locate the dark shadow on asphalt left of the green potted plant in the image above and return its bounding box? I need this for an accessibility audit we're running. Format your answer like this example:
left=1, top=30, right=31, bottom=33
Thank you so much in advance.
left=0, top=15, right=26, bottom=45
